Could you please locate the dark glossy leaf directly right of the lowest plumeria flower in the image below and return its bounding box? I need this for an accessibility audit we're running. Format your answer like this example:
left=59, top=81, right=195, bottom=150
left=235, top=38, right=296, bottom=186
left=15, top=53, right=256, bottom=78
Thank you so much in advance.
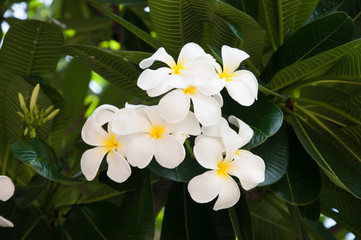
left=252, top=125, right=290, bottom=186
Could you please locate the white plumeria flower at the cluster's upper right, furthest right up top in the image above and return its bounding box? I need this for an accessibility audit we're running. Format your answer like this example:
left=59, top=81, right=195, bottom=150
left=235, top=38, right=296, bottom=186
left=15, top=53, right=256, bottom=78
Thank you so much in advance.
left=215, top=45, right=258, bottom=106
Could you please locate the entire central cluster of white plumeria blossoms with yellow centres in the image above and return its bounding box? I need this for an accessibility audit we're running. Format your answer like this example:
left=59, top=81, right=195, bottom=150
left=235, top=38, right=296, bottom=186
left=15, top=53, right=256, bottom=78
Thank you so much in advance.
left=81, top=43, right=265, bottom=210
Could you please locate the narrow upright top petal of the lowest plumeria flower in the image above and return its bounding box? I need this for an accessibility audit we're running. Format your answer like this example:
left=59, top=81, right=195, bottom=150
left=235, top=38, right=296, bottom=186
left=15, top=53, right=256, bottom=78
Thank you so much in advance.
left=221, top=125, right=243, bottom=160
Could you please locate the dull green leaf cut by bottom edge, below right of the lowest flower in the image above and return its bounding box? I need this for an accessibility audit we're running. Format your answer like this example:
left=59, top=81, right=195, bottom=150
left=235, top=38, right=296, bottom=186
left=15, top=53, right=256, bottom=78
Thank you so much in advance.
left=248, top=195, right=297, bottom=240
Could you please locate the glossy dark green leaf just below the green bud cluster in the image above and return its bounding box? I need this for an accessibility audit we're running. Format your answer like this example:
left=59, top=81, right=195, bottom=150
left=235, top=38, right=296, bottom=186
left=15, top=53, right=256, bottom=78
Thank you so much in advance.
left=10, top=138, right=76, bottom=182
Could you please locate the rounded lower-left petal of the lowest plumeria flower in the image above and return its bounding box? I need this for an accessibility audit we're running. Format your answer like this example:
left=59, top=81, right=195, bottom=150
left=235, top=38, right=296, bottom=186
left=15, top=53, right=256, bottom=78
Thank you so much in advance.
left=188, top=170, right=222, bottom=203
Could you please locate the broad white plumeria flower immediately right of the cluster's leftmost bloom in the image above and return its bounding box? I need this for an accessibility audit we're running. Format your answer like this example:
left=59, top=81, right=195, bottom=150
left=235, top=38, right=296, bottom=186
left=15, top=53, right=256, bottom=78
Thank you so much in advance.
left=112, top=106, right=200, bottom=168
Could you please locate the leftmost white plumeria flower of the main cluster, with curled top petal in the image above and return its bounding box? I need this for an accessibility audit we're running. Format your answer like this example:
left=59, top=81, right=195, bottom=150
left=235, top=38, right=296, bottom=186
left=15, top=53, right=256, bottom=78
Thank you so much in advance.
left=80, top=105, right=131, bottom=183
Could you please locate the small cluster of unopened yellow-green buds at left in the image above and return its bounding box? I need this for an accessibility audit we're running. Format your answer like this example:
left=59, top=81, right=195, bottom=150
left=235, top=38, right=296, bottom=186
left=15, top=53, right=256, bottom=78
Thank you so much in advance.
left=18, top=84, right=60, bottom=138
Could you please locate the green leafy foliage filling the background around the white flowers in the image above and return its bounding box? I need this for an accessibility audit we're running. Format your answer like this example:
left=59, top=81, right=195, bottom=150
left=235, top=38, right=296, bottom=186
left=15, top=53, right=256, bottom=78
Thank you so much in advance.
left=0, top=0, right=361, bottom=240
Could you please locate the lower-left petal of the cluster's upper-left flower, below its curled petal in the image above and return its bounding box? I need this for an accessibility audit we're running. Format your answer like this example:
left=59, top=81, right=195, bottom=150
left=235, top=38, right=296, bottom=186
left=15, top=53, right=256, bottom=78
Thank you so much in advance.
left=137, top=67, right=171, bottom=90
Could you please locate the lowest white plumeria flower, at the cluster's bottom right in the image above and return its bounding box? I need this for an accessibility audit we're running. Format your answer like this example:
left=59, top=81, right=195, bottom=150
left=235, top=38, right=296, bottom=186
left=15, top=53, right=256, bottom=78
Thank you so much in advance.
left=188, top=117, right=265, bottom=210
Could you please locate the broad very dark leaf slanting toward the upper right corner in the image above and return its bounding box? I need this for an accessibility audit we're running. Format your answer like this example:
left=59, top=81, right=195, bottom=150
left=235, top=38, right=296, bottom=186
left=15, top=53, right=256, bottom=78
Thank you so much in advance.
left=261, top=12, right=353, bottom=83
